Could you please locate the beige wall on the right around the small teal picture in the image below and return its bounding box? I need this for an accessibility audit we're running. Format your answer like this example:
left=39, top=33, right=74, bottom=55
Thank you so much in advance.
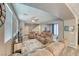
left=64, top=19, right=78, bottom=48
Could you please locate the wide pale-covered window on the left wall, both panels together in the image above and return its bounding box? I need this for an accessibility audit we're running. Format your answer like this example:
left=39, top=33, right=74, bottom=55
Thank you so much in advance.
left=4, top=7, right=18, bottom=43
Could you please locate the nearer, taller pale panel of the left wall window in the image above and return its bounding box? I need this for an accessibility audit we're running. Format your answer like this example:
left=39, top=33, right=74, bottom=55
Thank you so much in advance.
left=4, top=7, right=12, bottom=43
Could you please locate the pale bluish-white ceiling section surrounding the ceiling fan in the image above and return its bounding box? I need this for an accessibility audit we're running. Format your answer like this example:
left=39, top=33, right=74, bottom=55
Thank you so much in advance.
left=13, top=4, right=57, bottom=24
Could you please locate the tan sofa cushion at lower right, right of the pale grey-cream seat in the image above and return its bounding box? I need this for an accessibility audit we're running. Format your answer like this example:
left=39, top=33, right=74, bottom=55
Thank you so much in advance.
left=46, top=42, right=64, bottom=56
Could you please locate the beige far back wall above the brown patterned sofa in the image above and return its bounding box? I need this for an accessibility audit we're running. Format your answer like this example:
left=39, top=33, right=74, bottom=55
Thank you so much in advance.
left=21, top=24, right=52, bottom=34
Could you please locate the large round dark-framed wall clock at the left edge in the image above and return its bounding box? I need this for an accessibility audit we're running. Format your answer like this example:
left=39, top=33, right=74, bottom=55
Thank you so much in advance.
left=0, top=3, right=6, bottom=27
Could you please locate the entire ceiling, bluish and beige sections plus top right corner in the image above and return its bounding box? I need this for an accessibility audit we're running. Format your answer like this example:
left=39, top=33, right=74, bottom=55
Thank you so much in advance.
left=12, top=3, right=79, bottom=23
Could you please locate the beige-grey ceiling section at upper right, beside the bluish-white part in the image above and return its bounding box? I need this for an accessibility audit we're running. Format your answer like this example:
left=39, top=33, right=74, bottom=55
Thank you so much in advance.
left=25, top=3, right=74, bottom=20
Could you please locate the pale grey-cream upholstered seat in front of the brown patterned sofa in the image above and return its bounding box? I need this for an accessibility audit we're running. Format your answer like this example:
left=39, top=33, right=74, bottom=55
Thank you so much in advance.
left=22, top=39, right=43, bottom=54
